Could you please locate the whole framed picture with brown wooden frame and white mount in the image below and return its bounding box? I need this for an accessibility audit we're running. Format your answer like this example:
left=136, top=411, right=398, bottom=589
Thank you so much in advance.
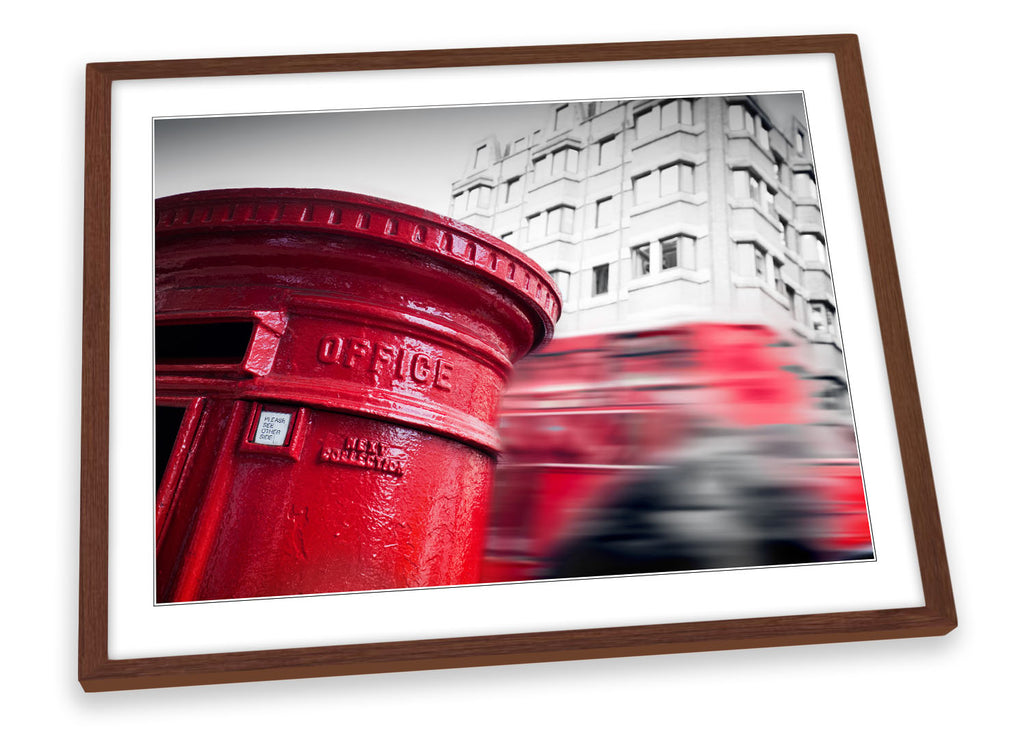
left=79, top=36, right=955, bottom=691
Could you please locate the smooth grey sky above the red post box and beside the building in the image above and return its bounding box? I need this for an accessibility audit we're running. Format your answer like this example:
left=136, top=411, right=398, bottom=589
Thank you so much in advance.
left=154, top=94, right=803, bottom=214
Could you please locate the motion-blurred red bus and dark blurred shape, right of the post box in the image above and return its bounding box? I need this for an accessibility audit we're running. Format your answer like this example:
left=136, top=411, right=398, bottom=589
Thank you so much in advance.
left=484, top=322, right=873, bottom=581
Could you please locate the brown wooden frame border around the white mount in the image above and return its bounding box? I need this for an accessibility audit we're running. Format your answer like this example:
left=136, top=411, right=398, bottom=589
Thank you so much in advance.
left=79, top=35, right=956, bottom=691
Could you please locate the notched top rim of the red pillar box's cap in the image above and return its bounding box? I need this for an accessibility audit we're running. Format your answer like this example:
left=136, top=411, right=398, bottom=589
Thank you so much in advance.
left=156, top=188, right=562, bottom=347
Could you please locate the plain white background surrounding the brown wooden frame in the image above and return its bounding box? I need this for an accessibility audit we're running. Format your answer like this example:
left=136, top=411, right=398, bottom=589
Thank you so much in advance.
left=0, top=0, right=1024, bottom=735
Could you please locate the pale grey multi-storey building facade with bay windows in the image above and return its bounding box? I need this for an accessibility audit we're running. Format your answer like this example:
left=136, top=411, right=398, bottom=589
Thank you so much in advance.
left=450, top=96, right=850, bottom=425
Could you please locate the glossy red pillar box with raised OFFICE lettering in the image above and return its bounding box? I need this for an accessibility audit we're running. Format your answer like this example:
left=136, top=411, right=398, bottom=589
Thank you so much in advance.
left=156, top=189, right=561, bottom=602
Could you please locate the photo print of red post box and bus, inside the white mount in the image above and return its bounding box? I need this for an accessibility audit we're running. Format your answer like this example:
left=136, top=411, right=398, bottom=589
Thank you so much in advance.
left=154, top=92, right=873, bottom=604
